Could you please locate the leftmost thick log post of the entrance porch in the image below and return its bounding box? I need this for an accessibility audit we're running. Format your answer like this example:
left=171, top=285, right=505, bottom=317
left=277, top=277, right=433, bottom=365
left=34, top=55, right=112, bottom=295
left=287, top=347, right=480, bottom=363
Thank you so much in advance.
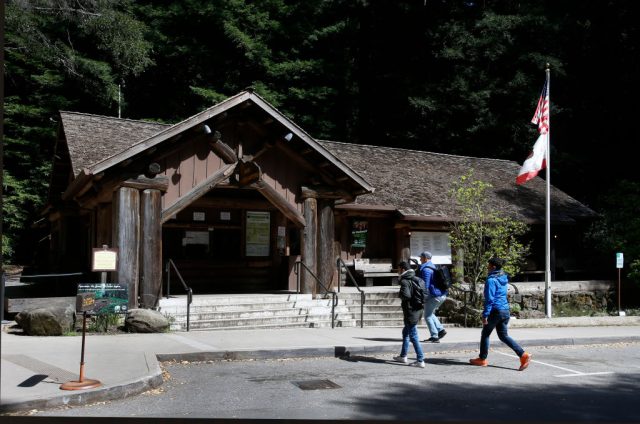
left=113, top=187, right=140, bottom=309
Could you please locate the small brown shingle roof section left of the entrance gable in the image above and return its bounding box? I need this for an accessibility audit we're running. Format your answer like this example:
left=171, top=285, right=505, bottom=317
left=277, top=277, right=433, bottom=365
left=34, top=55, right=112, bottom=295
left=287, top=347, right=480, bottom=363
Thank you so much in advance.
left=60, top=112, right=170, bottom=176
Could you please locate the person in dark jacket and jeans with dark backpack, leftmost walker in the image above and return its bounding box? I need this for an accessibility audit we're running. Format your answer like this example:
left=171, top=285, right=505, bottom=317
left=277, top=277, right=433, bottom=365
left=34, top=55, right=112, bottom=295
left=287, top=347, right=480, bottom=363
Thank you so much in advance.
left=393, top=261, right=425, bottom=368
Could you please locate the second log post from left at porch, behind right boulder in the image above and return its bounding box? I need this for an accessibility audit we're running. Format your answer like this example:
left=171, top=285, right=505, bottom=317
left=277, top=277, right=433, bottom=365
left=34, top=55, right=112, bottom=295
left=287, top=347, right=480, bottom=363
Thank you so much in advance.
left=140, top=189, right=162, bottom=309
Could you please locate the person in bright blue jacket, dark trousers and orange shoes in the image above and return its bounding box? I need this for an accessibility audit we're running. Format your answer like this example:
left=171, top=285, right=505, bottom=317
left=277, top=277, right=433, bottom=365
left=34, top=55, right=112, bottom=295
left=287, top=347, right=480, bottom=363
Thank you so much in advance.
left=469, top=257, right=531, bottom=371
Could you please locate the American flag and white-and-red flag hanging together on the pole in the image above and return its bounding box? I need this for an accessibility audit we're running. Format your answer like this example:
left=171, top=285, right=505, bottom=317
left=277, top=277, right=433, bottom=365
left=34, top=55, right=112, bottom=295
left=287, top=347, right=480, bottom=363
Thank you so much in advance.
left=516, top=79, right=549, bottom=184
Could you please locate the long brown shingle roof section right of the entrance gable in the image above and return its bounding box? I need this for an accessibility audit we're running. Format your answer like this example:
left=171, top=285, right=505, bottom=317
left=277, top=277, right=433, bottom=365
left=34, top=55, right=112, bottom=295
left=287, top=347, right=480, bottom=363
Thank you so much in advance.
left=319, top=141, right=596, bottom=223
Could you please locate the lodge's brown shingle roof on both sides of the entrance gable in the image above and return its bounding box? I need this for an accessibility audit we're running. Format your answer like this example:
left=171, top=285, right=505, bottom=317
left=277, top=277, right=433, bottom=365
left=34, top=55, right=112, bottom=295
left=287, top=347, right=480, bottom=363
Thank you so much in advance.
left=55, top=112, right=595, bottom=227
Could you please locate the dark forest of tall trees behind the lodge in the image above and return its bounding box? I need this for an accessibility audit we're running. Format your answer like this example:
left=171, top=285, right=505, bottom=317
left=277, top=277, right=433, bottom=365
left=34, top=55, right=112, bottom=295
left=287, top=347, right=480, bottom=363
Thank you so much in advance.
left=2, top=0, right=640, bottom=281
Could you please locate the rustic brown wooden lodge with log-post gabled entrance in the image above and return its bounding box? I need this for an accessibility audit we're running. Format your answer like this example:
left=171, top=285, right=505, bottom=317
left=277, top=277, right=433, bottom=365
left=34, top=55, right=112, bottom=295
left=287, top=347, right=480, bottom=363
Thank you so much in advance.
left=45, top=91, right=595, bottom=308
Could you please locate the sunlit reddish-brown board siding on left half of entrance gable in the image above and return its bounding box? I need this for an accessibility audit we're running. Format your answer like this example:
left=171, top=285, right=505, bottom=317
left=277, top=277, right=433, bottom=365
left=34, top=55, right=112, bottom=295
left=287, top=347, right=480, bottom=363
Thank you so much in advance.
left=161, top=138, right=225, bottom=210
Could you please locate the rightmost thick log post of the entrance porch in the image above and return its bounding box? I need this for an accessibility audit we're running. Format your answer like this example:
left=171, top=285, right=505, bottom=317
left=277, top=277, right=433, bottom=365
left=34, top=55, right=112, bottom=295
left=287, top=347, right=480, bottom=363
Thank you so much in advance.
left=317, top=199, right=336, bottom=289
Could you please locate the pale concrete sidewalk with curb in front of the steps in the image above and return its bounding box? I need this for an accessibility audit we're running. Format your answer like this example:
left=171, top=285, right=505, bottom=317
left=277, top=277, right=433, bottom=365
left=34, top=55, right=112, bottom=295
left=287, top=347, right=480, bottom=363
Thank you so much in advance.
left=0, top=317, right=640, bottom=413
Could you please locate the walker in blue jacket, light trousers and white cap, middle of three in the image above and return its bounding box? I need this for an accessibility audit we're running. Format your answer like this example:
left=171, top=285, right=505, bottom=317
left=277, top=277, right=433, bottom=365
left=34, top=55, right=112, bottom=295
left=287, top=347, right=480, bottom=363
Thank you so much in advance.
left=418, top=251, right=448, bottom=343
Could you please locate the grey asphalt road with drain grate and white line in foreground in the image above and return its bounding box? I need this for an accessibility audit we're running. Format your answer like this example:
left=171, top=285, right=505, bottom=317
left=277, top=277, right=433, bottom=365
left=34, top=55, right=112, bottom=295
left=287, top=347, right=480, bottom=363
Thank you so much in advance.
left=17, top=343, right=640, bottom=422
